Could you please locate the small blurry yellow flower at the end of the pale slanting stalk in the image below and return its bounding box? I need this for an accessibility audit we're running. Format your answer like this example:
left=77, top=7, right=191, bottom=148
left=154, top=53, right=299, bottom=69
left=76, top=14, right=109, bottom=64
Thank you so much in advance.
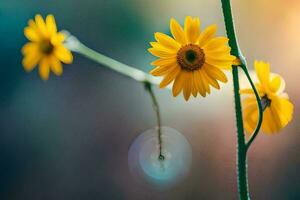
left=22, top=15, right=73, bottom=80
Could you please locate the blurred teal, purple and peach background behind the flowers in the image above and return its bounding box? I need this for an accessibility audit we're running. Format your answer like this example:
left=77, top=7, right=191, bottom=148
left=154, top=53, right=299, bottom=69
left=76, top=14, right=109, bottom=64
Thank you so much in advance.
left=0, top=0, right=300, bottom=200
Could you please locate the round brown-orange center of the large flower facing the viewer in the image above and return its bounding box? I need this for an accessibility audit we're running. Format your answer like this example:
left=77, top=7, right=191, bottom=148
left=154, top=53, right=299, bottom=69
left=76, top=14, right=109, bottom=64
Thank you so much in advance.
left=177, top=44, right=205, bottom=71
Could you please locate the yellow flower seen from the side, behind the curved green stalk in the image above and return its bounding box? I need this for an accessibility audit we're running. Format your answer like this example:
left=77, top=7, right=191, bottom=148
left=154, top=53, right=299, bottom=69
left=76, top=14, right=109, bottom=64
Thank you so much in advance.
left=240, top=61, right=294, bottom=134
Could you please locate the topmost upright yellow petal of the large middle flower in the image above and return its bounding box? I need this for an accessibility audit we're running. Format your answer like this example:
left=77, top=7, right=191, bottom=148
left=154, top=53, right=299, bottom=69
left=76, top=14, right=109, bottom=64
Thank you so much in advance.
left=184, top=16, right=200, bottom=44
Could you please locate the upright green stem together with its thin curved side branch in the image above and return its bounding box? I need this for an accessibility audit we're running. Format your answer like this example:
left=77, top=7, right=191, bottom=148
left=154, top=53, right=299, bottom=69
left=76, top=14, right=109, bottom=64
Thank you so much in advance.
left=221, top=0, right=263, bottom=200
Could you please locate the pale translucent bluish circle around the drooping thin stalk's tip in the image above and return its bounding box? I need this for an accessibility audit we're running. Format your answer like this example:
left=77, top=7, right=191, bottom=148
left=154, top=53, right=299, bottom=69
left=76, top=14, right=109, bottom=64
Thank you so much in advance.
left=128, top=127, right=192, bottom=189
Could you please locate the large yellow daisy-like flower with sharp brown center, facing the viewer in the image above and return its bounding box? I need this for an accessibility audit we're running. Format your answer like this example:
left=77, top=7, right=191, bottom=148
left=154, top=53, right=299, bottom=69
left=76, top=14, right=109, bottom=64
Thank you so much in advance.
left=148, top=16, right=235, bottom=100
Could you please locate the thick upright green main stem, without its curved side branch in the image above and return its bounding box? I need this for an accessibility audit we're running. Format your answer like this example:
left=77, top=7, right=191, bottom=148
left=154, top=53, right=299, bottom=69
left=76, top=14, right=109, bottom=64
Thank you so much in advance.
left=221, top=0, right=250, bottom=200
